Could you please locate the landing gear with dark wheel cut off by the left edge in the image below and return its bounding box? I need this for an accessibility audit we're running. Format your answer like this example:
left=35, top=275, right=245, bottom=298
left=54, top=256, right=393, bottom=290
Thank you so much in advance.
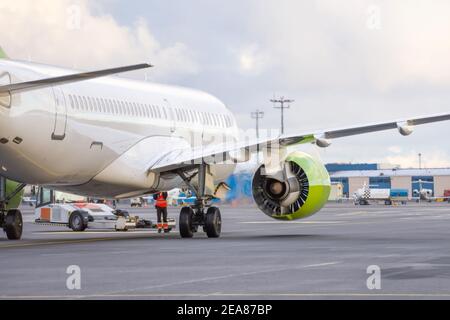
left=0, top=177, right=25, bottom=240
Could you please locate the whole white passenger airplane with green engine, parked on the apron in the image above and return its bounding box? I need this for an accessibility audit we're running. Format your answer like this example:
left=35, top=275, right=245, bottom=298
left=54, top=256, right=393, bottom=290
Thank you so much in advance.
left=0, top=44, right=450, bottom=240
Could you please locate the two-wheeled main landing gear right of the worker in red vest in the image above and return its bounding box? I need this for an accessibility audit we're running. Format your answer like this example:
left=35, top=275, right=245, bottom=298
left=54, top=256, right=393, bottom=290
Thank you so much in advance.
left=178, top=164, right=222, bottom=238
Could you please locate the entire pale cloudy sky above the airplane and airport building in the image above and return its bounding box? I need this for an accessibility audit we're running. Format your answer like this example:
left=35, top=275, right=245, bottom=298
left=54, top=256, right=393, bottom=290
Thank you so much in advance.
left=0, top=0, right=450, bottom=167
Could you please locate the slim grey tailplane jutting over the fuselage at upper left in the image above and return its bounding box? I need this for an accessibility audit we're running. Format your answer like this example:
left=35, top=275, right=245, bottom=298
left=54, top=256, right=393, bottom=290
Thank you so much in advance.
left=0, top=63, right=152, bottom=95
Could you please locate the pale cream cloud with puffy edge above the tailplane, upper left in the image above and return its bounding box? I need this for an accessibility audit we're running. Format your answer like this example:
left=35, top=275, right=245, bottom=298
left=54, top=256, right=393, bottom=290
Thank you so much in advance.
left=0, top=0, right=198, bottom=80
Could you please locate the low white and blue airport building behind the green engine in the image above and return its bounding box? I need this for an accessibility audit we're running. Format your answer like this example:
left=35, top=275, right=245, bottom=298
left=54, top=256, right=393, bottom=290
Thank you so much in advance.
left=326, top=163, right=450, bottom=197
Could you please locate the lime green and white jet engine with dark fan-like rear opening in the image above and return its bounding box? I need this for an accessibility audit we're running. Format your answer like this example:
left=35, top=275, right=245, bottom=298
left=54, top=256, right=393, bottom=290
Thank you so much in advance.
left=252, top=152, right=331, bottom=220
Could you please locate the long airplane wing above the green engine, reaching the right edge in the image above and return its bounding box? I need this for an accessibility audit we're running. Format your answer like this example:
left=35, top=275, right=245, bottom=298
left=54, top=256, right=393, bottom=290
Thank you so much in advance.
left=150, top=113, right=450, bottom=172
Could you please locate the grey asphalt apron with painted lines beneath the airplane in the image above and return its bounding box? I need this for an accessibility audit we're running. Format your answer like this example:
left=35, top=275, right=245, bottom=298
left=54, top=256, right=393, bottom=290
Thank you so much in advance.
left=0, top=203, right=450, bottom=300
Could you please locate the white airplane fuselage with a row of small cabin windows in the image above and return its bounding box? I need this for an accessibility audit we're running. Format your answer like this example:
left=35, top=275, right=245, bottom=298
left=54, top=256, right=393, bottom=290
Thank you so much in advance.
left=0, top=60, right=237, bottom=197
